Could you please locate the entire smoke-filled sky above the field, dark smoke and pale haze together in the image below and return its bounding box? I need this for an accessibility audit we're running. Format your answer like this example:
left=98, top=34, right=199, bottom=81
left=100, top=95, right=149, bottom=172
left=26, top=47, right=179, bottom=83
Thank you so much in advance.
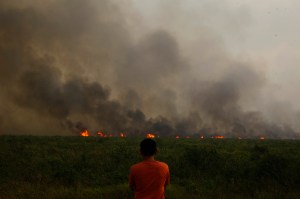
left=0, top=0, right=300, bottom=136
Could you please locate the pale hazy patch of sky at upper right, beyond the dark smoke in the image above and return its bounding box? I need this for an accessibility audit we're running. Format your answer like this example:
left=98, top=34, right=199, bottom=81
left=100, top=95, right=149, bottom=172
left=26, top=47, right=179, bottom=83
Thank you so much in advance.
left=133, top=0, right=300, bottom=104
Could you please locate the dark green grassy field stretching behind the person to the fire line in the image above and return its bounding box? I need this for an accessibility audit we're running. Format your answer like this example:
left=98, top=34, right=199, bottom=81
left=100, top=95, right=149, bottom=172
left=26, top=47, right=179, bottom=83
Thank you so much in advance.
left=0, top=136, right=300, bottom=199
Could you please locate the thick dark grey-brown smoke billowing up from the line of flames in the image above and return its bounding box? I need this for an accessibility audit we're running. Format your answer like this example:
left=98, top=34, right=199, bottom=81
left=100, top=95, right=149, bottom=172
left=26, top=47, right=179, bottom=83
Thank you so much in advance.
left=0, top=0, right=299, bottom=138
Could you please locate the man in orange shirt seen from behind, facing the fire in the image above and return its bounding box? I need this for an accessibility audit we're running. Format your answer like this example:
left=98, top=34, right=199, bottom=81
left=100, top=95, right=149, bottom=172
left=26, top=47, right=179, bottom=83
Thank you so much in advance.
left=129, top=138, right=170, bottom=199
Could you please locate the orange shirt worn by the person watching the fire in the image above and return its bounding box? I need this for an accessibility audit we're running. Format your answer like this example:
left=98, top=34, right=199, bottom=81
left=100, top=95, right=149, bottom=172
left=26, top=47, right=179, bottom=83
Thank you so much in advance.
left=129, top=160, right=170, bottom=199
